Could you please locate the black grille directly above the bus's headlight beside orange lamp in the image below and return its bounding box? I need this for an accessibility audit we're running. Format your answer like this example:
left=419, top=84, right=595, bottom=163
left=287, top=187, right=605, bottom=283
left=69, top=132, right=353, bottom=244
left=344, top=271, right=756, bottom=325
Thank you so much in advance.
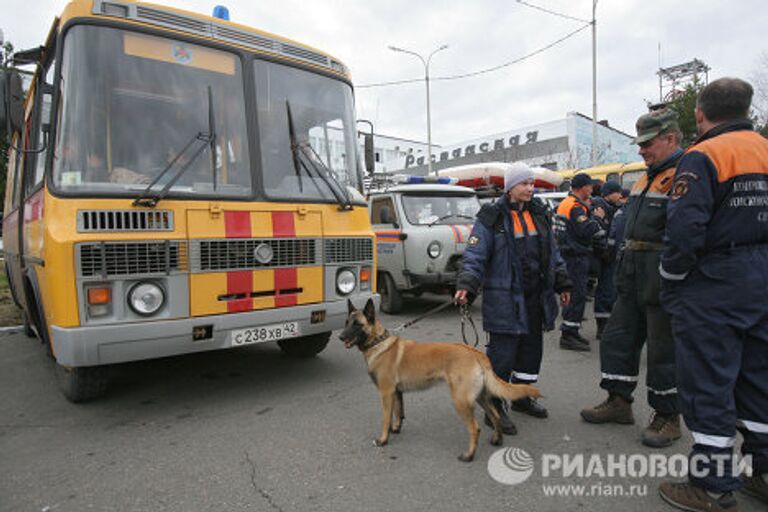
left=76, top=240, right=187, bottom=277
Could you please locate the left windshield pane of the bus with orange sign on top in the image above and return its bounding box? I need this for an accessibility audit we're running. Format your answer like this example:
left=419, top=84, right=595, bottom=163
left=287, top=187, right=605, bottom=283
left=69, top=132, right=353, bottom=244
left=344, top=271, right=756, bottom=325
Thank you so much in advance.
left=53, top=26, right=252, bottom=198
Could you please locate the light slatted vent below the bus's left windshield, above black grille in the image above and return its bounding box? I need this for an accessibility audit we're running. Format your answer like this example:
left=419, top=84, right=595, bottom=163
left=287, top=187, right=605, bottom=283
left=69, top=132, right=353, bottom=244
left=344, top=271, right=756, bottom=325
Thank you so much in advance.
left=77, top=210, right=173, bottom=233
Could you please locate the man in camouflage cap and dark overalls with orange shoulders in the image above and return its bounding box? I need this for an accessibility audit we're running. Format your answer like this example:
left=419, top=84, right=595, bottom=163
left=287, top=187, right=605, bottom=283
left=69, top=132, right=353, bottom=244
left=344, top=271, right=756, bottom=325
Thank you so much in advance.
left=581, top=110, right=683, bottom=448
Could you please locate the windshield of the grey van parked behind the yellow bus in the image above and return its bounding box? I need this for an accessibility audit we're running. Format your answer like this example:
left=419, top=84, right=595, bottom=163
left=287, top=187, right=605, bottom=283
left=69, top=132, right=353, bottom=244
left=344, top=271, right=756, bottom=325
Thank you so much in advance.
left=402, top=194, right=480, bottom=225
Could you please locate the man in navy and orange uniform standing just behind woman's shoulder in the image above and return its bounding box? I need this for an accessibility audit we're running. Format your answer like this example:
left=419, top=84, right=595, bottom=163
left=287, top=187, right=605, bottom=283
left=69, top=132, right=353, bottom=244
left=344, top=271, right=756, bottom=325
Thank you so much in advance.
left=555, top=173, right=605, bottom=351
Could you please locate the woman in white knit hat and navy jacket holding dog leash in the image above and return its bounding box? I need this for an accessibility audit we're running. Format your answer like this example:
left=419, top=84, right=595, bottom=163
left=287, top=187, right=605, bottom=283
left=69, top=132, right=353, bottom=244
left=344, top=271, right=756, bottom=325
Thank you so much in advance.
left=455, top=162, right=572, bottom=435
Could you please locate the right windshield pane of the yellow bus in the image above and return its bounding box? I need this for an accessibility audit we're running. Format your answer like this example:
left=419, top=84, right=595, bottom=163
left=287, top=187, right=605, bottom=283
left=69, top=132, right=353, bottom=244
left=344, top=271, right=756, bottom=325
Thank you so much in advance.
left=254, top=61, right=365, bottom=204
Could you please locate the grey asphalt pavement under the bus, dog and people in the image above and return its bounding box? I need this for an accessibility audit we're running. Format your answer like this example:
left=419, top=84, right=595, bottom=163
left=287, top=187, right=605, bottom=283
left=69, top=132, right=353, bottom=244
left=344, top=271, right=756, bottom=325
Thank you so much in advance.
left=0, top=297, right=765, bottom=512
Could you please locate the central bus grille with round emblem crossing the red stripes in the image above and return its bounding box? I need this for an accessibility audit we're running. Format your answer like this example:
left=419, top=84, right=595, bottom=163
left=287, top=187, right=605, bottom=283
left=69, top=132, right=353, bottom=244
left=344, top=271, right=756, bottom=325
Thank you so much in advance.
left=191, top=238, right=320, bottom=272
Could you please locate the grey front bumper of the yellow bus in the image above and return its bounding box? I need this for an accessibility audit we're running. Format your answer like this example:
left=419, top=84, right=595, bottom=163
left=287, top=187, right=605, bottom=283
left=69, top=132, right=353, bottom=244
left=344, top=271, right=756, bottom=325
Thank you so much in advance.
left=51, top=293, right=380, bottom=366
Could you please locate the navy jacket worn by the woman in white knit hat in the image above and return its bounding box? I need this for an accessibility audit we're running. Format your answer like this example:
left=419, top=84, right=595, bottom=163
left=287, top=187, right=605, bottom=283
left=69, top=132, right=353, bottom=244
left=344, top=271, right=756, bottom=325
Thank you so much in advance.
left=456, top=195, right=572, bottom=334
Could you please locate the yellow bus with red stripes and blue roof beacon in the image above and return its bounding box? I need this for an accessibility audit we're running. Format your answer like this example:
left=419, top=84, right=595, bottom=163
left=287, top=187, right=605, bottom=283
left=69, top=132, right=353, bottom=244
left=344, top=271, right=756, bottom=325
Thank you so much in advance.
left=0, top=0, right=379, bottom=402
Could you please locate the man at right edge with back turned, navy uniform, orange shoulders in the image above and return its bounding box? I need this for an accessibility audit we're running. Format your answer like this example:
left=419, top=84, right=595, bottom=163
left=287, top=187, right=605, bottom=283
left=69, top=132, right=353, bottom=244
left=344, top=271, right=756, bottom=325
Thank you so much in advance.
left=659, top=78, right=768, bottom=511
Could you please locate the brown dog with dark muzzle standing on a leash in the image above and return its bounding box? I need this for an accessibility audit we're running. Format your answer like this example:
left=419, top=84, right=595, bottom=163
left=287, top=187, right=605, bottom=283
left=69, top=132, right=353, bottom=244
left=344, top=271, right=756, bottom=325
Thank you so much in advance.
left=339, top=299, right=541, bottom=462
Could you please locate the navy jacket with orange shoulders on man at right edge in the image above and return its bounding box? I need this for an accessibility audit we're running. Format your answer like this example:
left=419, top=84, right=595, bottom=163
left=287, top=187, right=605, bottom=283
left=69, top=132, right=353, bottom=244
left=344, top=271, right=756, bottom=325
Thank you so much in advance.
left=661, top=121, right=768, bottom=281
